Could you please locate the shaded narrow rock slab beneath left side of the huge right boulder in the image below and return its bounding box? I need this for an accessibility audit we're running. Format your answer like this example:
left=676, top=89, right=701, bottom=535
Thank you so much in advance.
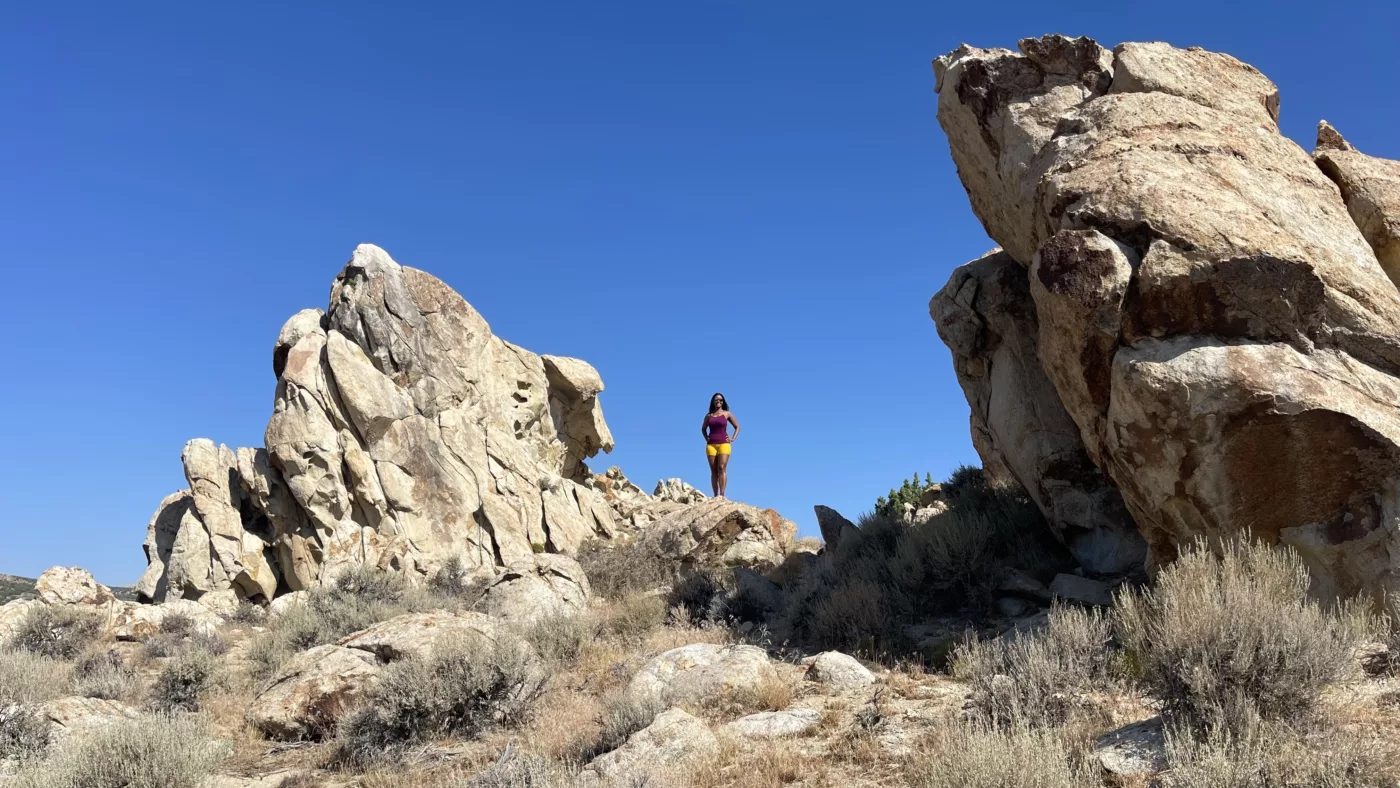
left=928, top=252, right=1147, bottom=574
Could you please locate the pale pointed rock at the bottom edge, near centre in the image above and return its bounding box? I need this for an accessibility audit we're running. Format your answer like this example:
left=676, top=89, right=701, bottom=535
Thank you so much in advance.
left=585, top=708, right=720, bottom=787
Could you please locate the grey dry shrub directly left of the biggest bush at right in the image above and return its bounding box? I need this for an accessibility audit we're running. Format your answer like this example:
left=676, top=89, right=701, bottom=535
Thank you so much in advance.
left=952, top=607, right=1120, bottom=725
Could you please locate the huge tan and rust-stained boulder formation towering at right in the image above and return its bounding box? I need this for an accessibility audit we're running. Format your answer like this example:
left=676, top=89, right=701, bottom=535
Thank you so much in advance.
left=932, top=36, right=1400, bottom=593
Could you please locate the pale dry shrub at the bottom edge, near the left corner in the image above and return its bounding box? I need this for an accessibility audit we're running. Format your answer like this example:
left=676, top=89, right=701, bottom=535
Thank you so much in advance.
left=14, top=715, right=224, bottom=788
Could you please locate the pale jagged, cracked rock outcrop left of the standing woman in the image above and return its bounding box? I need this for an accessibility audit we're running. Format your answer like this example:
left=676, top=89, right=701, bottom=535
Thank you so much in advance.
left=137, top=245, right=615, bottom=600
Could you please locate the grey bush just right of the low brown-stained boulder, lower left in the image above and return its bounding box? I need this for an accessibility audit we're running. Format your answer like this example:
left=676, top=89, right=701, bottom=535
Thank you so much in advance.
left=340, top=638, right=543, bottom=766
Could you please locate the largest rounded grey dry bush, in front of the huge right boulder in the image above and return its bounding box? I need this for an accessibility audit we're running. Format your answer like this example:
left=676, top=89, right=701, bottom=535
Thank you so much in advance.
left=1117, top=542, right=1372, bottom=731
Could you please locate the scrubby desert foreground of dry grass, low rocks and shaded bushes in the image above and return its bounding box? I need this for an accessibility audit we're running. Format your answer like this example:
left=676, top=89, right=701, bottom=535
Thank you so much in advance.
left=0, top=487, right=1400, bottom=788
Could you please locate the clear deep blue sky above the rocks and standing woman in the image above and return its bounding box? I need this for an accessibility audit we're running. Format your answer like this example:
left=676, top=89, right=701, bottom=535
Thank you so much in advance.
left=0, top=0, right=1400, bottom=584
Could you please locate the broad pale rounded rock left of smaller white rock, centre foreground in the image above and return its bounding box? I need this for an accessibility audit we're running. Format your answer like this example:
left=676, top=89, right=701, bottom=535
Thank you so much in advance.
left=627, top=642, right=778, bottom=705
